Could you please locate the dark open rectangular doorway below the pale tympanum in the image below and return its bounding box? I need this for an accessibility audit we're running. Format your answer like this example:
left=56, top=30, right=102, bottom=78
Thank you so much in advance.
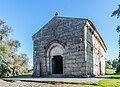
left=52, top=55, right=63, bottom=74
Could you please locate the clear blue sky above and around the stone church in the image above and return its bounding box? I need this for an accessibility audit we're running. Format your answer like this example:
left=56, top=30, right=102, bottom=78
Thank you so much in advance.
left=0, top=0, right=120, bottom=66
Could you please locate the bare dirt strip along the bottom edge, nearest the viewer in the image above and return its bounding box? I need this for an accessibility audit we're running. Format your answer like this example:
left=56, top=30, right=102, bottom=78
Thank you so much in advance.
left=0, top=80, right=98, bottom=87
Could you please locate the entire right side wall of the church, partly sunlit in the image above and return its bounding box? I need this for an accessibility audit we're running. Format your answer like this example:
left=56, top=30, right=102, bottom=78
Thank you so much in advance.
left=85, top=22, right=105, bottom=76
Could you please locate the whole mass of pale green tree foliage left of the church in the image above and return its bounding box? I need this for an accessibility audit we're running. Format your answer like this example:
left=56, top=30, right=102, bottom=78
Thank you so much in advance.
left=0, top=19, right=28, bottom=77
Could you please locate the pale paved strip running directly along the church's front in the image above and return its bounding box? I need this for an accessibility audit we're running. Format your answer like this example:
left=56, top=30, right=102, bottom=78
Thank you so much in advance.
left=3, top=75, right=113, bottom=82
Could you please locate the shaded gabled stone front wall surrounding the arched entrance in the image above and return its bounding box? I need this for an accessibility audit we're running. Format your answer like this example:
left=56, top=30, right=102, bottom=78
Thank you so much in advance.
left=33, top=18, right=86, bottom=76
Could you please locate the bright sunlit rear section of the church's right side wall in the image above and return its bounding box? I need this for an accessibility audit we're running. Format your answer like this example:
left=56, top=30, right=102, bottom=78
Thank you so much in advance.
left=93, top=29, right=105, bottom=76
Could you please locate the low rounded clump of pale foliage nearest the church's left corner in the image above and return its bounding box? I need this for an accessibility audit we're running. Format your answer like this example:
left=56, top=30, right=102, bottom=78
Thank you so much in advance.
left=7, top=54, right=28, bottom=76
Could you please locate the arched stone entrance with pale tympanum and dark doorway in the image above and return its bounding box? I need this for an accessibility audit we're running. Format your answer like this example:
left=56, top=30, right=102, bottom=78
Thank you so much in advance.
left=47, top=43, right=64, bottom=74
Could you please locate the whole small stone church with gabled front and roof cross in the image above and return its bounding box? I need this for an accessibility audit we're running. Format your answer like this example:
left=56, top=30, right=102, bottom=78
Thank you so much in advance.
left=32, top=13, right=107, bottom=77
